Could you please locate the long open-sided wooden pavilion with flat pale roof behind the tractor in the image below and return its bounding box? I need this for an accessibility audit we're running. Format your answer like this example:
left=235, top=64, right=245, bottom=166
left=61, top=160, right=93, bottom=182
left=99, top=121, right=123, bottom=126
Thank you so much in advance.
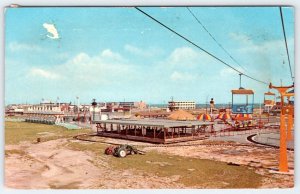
left=93, top=119, right=214, bottom=144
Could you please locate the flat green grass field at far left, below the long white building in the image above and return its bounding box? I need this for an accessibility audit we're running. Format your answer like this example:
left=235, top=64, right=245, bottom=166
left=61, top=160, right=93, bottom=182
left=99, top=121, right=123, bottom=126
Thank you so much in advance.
left=5, top=121, right=90, bottom=144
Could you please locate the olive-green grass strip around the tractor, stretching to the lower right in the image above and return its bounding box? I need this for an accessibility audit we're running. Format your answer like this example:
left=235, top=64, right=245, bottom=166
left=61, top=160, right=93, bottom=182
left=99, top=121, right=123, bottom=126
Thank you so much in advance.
left=68, top=142, right=263, bottom=188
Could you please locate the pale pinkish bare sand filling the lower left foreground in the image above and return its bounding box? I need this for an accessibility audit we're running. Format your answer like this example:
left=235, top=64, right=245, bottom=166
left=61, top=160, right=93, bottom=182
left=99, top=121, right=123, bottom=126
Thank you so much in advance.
left=5, top=139, right=183, bottom=189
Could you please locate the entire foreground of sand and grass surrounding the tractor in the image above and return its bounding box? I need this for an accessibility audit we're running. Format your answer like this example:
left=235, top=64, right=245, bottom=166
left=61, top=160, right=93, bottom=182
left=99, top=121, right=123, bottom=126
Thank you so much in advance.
left=5, top=123, right=294, bottom=189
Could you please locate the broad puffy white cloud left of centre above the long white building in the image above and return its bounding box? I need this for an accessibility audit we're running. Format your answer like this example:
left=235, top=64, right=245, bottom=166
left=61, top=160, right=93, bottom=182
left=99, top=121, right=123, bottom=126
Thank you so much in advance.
left=29, top=49, right=135, bottom=86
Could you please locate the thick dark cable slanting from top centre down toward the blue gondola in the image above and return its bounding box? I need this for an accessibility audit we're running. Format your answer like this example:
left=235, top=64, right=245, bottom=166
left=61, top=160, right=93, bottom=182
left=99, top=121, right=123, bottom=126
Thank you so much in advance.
left=135, top=7, right=269, bottom=85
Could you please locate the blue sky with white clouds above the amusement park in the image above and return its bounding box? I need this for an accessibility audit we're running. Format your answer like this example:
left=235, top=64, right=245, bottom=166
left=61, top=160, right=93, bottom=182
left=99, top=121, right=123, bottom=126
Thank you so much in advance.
left=5, top=7, right=294, bottom=104
